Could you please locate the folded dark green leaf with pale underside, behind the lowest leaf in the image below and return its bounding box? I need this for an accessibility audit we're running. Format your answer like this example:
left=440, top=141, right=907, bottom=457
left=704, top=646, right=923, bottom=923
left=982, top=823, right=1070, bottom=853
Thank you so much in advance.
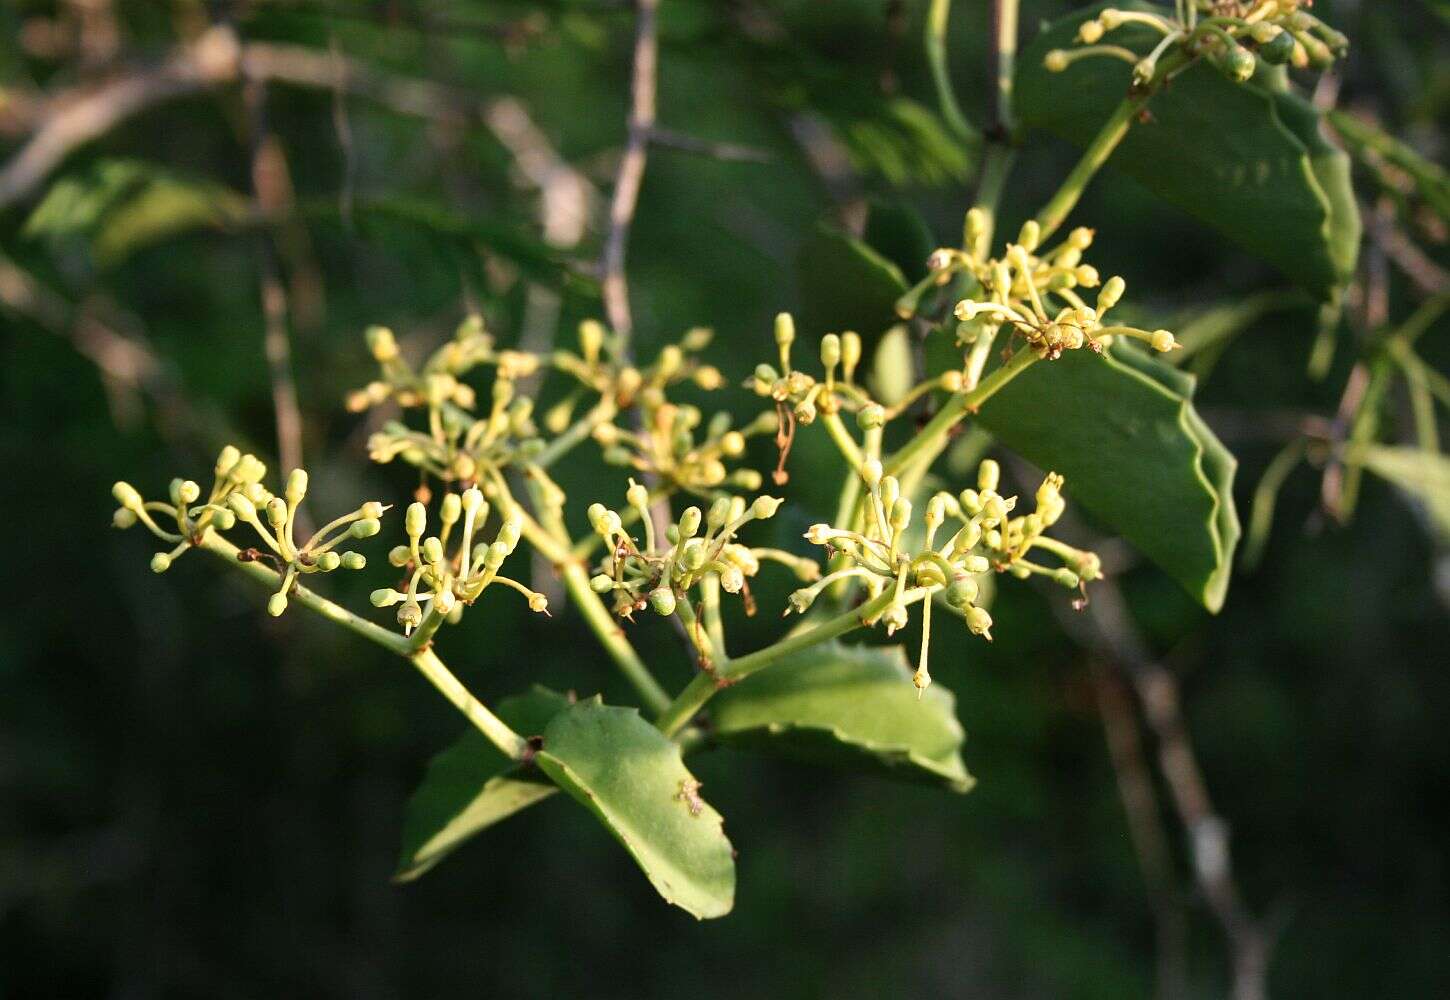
left=393, top=686, right=571, bottom=883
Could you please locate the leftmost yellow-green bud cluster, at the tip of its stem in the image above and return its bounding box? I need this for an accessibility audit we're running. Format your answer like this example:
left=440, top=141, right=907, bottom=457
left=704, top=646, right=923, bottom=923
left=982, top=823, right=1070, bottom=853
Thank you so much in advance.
left=112, top=445, right=387, bottom=616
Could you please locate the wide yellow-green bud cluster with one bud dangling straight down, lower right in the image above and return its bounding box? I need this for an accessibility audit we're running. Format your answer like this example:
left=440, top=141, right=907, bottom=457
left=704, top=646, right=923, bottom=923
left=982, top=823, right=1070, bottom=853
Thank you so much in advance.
left=786, top=459, right=1102, bottom=690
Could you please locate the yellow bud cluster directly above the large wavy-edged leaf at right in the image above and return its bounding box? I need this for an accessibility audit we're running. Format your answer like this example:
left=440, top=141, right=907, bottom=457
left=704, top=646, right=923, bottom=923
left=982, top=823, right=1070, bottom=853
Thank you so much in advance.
left=951, top=209, right=1177, bottom=359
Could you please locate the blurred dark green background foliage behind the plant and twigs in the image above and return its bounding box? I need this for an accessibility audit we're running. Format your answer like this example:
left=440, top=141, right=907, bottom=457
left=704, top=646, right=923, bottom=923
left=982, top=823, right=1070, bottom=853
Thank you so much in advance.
left=0, top=0, right=1450, bottom=997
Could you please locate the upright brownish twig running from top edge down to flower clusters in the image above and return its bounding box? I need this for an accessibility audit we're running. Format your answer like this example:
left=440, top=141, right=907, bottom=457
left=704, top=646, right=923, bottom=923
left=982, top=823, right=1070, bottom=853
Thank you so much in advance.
left=599, top=0, right=660, bottom=346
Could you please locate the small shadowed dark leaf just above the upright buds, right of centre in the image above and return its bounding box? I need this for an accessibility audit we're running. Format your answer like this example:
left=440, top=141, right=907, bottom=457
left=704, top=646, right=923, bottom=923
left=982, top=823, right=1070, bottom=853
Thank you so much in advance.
left=799, top=222, right=906, bottom=339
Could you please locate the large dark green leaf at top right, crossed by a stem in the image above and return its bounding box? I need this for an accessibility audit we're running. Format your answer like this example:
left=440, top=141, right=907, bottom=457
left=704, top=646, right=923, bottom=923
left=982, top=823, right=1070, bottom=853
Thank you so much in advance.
left=1015, top=3, right=1360, bottom=297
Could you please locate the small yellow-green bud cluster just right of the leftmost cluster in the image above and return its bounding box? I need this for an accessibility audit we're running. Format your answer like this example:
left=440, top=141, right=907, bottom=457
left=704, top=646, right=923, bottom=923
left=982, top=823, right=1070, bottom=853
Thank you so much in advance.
left=371, top=487, right=548, bottom=635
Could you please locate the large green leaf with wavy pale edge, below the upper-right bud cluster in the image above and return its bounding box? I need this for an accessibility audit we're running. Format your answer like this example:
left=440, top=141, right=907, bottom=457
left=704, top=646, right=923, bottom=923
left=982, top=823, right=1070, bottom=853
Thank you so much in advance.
left=977, top=348, right=1240, bottom=612
